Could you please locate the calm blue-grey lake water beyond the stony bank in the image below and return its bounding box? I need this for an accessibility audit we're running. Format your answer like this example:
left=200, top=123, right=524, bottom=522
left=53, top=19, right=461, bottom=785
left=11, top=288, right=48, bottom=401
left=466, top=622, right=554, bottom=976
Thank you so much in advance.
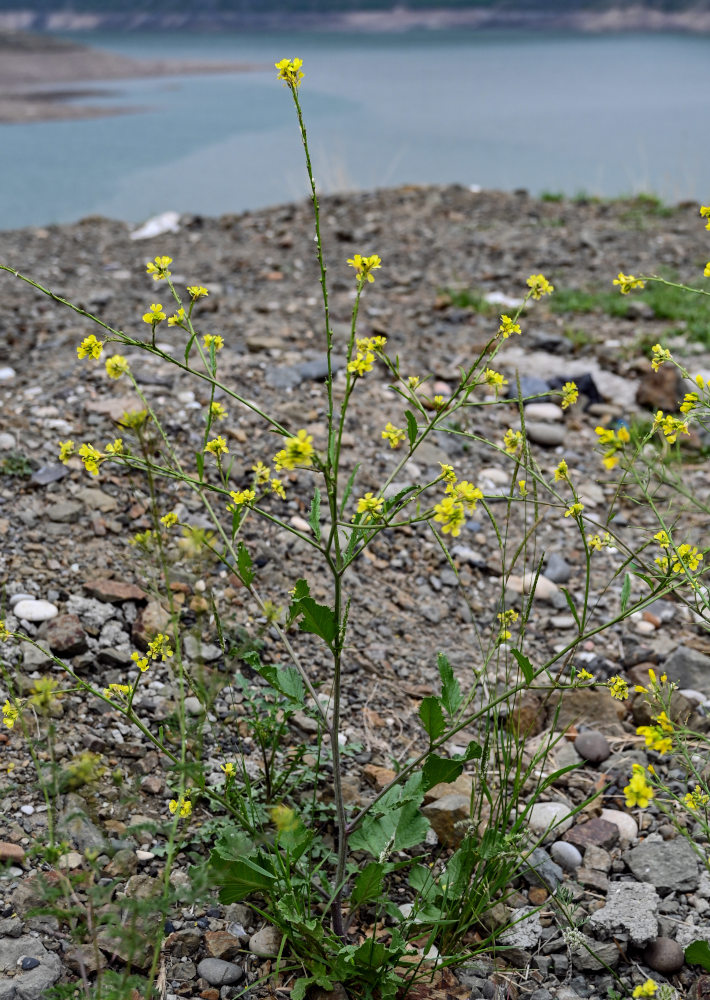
left=0, top=32, right=710, bottom=229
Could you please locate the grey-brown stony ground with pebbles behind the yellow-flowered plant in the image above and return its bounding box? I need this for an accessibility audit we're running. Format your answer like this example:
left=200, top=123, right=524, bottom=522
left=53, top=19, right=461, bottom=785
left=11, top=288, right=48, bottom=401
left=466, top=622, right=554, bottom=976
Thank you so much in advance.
left=0, top=187, right=710, bottom=1000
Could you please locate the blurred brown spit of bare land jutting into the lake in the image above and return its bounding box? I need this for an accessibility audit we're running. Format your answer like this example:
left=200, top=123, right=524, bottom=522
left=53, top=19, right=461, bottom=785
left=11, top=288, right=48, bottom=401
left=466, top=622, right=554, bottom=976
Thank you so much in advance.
left=0, top=32, right=257, bottom=124
